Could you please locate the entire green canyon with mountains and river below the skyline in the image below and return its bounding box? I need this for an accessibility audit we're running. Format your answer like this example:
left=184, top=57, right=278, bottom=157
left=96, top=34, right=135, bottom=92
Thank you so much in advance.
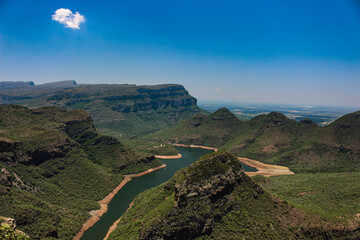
left=0, top=81, right=360, bottom=239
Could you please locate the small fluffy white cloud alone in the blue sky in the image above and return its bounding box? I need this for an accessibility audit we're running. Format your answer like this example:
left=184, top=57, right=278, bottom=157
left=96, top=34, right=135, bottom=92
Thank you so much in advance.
left=52, top=8, right=85, bottom=29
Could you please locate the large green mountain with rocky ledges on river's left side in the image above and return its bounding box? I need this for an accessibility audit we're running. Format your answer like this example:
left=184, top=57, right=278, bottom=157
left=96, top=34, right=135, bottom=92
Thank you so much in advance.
left=0, top=105, right=162, bottom=239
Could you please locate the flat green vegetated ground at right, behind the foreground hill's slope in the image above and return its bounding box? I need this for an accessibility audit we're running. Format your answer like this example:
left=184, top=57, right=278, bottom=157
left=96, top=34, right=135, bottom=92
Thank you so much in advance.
left=257, top=172, right=360, bottom=221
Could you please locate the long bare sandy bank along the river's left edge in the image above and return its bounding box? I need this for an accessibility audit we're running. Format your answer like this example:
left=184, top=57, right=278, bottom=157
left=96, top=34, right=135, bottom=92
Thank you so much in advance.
left=73, top=164, right=166, bottom=240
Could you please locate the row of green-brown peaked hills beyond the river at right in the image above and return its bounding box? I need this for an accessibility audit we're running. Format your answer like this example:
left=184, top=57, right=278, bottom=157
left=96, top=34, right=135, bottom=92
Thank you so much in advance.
left=140, top=108, right=360, bottom=172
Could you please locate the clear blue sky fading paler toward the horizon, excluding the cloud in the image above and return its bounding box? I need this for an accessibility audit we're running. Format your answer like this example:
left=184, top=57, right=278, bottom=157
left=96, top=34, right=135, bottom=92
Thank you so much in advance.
left=0, top=0, right=360, bottom=107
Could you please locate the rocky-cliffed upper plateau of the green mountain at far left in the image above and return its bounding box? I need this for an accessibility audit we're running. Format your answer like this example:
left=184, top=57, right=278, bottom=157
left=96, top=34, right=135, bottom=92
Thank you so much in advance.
left=0, top=105, right=94, bottom=166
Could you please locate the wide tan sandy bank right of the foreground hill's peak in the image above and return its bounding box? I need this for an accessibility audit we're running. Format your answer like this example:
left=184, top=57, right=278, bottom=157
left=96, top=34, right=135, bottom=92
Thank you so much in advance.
left=237, top=157, right=295, bottom=177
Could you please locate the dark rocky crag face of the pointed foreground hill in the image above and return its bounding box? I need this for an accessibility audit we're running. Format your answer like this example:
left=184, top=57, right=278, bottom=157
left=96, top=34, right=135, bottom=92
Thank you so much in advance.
left=139, top=153, right=263, bottom=239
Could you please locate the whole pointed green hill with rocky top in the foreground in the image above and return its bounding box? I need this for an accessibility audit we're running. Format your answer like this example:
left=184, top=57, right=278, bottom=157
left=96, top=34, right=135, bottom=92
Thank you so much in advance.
left=109, top=152, right=359, bottom=239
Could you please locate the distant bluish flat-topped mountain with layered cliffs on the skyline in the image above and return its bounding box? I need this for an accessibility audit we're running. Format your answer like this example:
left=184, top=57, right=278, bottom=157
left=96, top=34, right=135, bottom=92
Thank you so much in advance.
left=0, top=81, right=203, bottom=139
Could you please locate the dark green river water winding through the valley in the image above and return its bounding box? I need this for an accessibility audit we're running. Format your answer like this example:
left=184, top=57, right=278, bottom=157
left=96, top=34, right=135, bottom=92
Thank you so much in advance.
left=81, top=147, right=256, bottom=240
